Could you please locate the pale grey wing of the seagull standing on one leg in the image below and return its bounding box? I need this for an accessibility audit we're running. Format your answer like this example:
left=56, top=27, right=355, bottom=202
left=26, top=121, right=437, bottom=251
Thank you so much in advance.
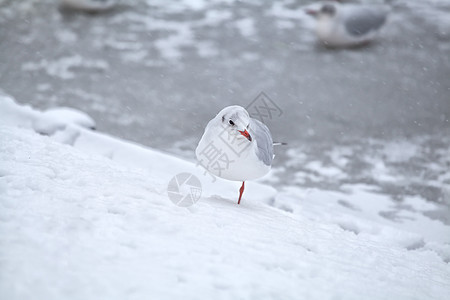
left=249, top=118, right=273, bottom=166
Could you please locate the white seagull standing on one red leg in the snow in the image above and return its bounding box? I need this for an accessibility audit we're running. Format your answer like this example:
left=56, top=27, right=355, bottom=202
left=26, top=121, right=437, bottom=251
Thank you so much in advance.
left=195, top=105, right=282, bottom=204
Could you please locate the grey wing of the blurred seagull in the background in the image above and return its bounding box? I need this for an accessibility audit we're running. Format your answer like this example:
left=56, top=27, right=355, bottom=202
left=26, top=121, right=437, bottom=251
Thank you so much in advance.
left=345, top=7, right=387, bottom=36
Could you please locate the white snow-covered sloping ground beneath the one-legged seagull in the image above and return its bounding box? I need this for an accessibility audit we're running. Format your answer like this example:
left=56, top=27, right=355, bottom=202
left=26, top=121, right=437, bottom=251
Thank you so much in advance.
left=0, top=95, right=450, bottom=299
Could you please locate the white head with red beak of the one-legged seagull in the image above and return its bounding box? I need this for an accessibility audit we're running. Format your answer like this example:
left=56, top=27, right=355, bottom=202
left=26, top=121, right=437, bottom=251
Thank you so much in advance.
left=215, top=105, right=252, bottom=142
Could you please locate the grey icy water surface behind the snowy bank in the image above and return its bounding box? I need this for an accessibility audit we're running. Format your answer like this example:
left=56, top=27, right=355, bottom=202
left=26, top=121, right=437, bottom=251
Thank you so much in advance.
left=0, top=0, right=450, bottom=222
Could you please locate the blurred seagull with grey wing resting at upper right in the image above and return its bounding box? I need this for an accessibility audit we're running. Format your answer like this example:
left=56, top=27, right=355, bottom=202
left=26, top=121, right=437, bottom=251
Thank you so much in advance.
left=305, top=2, right=388, bottom=47
